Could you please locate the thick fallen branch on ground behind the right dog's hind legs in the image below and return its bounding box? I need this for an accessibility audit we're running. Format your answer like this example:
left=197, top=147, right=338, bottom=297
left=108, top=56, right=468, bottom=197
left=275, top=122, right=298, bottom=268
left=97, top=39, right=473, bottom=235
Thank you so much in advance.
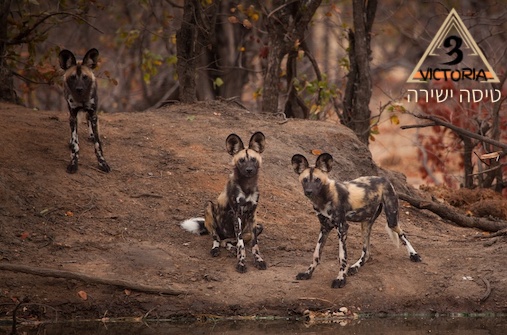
left=398, top=193, right=507, bottom=232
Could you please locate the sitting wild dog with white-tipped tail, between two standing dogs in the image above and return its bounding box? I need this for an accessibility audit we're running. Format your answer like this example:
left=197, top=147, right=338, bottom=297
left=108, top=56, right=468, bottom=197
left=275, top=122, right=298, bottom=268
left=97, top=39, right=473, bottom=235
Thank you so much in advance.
left=181, top=132, right=266, bottom=273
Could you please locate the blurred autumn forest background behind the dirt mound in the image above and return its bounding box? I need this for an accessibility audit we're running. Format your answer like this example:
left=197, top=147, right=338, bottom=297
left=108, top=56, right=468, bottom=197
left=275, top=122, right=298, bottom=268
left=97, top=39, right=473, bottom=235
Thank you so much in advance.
left=0, top=0, right=507, bottom=192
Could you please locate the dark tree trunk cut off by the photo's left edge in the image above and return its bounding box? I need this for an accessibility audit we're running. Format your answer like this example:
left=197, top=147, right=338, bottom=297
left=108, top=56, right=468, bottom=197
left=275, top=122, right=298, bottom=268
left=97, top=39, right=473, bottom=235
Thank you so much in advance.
left=0, top=0, right=17, bottom=103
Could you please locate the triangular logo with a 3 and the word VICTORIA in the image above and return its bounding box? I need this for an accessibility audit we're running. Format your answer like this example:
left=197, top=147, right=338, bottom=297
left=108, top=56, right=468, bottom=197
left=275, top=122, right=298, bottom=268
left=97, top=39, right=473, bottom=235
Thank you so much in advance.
left=407, top=8, right=500, bottom=83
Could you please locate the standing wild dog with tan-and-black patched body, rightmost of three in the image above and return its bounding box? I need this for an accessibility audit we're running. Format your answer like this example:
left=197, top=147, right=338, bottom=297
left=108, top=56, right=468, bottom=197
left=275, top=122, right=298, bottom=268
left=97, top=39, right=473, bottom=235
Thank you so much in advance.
left=292, top=153, right=421, bottom=288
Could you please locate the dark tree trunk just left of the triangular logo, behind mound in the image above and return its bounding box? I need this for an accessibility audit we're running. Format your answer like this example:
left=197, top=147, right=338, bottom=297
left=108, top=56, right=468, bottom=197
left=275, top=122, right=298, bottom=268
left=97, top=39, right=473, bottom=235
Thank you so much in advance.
left=339, top=0, right=377, bottom=144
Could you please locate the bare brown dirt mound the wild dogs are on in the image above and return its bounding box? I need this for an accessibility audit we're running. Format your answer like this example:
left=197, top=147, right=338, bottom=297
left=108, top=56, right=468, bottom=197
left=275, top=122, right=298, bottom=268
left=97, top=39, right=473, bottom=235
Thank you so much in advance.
left=0, top=102, right=507, bottom=319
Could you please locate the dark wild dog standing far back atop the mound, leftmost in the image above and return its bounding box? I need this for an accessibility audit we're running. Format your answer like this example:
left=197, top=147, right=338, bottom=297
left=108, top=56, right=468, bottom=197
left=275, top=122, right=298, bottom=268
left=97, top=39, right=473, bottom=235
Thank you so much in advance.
left=58, top=49, right=111, bottom=173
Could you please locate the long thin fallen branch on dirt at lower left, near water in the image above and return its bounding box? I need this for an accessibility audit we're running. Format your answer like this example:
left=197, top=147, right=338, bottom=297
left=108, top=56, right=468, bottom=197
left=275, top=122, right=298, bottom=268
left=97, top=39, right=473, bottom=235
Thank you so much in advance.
left=0, top=263, right=185, bottom=295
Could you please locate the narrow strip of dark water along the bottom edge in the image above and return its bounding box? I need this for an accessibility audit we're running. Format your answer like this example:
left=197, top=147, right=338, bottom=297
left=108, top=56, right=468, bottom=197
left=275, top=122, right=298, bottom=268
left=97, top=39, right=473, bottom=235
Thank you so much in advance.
left=0, top=317, right=507, bottom=335
